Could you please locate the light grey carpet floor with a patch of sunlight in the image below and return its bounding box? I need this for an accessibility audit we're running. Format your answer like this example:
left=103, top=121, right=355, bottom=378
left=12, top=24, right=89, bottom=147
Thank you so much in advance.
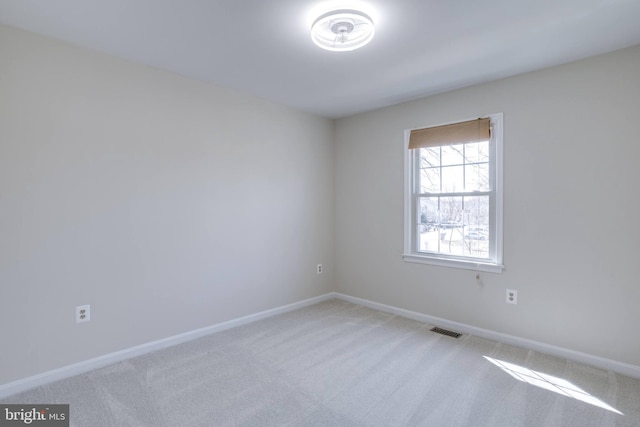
left=2, top=300, right=640, bottom=427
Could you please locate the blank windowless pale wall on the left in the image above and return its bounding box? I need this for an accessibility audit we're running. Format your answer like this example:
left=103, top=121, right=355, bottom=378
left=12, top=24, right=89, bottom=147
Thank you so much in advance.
left=0, top=27, right=334, bottom=384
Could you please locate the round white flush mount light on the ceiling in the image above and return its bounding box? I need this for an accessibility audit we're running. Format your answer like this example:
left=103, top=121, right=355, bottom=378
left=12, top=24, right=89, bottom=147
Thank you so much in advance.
left=311, top=9, right=373, bottom=52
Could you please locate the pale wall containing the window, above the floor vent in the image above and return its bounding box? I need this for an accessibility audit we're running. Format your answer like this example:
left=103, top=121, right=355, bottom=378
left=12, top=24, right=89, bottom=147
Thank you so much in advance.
left=336, top=46, right=640, bottom=365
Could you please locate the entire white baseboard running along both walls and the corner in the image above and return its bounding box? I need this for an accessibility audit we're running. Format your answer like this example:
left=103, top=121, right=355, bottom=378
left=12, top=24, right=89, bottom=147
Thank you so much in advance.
left=0, top=292, right=640, bottom=399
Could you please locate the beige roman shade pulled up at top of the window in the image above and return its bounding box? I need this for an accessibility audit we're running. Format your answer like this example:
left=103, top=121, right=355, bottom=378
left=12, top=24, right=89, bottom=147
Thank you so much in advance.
left=409, top=118, right=491, bottom=150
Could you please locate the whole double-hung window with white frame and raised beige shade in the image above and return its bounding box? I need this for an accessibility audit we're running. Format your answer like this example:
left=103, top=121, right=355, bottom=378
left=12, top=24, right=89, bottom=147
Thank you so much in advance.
left=403, top=113, right=503, bottom=272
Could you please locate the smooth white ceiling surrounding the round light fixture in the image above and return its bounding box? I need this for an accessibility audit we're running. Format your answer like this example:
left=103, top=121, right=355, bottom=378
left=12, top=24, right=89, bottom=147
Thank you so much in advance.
left=0, top=0, right=640, bottom=118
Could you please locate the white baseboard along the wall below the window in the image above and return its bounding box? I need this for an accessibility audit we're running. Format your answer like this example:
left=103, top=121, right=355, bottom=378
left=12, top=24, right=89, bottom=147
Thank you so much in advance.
left=332, top=292, right=640, bottom=379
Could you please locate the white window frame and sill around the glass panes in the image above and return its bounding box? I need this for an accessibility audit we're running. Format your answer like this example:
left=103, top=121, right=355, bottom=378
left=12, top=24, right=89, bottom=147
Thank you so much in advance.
left=402, top=113, right=504, bottom=273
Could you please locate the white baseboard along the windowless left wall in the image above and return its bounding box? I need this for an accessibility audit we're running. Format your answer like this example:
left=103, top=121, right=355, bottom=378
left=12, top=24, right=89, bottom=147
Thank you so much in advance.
left=0, top=293, right=335, bottom=399
